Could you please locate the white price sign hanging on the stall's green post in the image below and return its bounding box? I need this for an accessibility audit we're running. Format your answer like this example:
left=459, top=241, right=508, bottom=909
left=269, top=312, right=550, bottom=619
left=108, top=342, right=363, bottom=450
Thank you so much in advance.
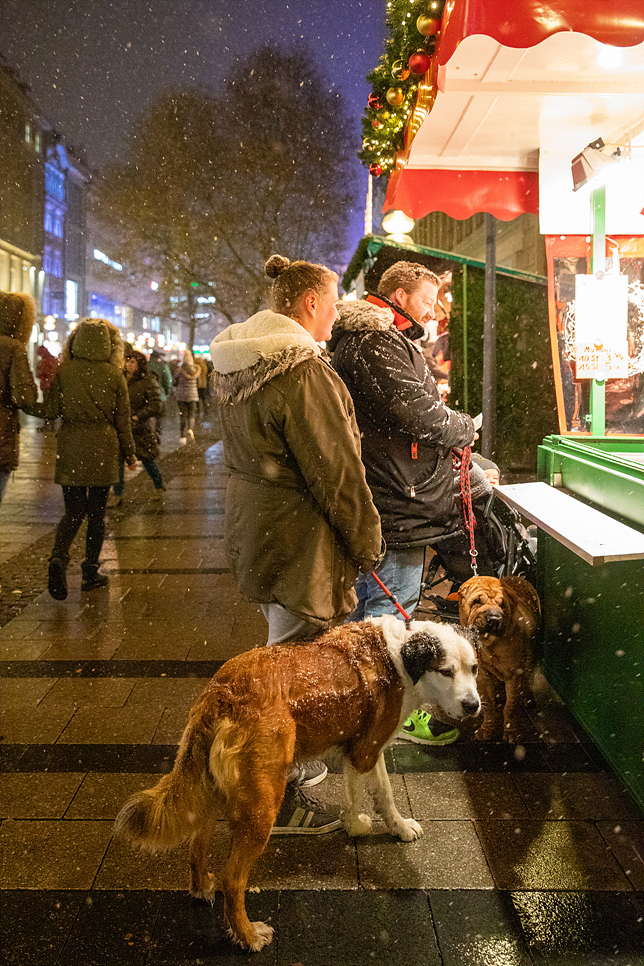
left=575, top=275, right=628, bottom=379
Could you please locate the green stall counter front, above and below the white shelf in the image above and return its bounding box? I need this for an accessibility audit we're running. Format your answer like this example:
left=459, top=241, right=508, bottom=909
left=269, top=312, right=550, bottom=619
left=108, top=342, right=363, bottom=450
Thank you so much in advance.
left=537, top=436, right=644, bottom=807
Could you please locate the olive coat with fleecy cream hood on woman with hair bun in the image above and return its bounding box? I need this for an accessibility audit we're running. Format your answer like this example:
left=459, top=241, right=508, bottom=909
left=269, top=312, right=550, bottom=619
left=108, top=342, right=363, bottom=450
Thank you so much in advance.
left=210, top=311, right=381, bottom=627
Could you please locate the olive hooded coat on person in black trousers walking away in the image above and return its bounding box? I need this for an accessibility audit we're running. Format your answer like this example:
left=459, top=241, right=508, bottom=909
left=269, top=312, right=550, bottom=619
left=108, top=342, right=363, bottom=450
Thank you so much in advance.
left=28, top=319, right=135, bottom=486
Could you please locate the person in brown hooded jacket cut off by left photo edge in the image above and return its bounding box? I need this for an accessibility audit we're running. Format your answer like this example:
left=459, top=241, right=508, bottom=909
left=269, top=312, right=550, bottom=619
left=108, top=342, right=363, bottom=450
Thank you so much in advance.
left=0, top=292, right=38, bottom=501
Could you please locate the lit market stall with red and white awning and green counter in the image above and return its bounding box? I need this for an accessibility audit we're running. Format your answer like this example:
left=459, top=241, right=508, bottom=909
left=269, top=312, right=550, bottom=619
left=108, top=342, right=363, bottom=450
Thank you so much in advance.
left=363, top=0, right=644, bottom=805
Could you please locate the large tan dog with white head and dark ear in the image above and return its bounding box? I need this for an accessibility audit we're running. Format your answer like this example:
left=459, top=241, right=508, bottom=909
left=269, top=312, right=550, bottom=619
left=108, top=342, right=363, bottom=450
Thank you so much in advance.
left=116, top=616, right=480, bottom=951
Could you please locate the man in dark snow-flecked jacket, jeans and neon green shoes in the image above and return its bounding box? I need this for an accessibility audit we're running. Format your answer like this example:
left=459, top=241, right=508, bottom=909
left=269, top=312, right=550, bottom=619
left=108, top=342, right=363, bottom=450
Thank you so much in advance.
left=327, top=262, right=475, bottom=744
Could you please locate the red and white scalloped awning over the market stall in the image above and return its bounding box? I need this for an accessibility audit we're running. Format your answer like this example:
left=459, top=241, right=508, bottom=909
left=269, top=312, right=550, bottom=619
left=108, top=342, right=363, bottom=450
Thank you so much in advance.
left=385, top=0, right=644, bottom=233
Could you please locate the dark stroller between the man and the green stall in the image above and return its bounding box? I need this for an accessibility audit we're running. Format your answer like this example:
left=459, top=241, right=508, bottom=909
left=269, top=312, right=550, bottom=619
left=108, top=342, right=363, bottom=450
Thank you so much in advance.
left=418, top=489, right=536, bottom=623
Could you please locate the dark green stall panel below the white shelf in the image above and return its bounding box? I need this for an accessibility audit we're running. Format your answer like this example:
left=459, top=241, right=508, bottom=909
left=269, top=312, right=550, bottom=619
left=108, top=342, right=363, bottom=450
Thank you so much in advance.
left=538, top=532, right=644, bottom=808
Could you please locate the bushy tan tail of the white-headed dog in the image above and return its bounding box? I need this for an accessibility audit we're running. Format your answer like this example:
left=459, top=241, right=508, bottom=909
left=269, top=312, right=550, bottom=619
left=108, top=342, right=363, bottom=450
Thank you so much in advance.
left=114, top=715, right=227, bottom=852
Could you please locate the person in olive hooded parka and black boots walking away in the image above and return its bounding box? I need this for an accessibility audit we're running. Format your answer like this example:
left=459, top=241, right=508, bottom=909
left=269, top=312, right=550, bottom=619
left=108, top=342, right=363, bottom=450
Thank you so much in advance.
left=25, top=319, right=136, bottom=600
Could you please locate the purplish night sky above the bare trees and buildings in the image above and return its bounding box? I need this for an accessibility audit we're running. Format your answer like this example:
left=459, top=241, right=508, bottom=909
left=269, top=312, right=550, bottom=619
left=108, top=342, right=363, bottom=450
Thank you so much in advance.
left=0, top=0, right=386, bottom=254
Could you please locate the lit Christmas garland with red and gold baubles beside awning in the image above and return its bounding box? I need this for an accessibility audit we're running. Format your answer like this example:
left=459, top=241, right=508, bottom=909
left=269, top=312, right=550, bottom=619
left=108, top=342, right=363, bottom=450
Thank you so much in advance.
left=358, top=0, right=445, bottom=177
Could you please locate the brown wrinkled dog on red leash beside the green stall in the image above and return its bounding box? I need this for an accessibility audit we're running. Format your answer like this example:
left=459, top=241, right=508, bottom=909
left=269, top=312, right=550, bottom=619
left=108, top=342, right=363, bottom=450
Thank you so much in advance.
left=458, top=577, right=541, bottom=744
